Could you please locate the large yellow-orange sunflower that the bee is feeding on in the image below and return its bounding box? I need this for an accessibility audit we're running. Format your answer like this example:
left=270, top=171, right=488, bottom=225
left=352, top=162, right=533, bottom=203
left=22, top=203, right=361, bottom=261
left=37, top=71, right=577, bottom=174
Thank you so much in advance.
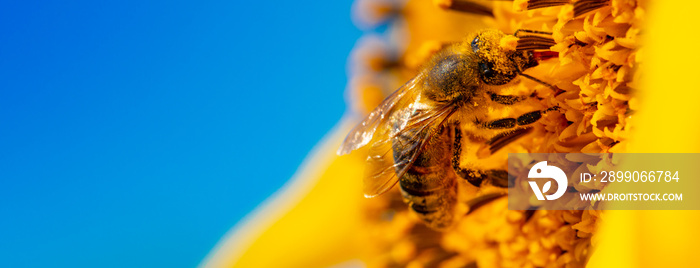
left=200, top=0, right=700, bottom=267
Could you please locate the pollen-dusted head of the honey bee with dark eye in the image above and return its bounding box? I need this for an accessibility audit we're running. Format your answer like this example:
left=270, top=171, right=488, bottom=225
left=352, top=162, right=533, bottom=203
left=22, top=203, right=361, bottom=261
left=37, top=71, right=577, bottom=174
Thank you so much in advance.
left=471, top=30, right=537, bottom=85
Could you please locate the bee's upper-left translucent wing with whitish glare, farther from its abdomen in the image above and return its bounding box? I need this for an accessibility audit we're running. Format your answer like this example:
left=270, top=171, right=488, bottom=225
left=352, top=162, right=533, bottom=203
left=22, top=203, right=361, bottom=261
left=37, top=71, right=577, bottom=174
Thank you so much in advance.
left=337, top=73, right=423, bottom=155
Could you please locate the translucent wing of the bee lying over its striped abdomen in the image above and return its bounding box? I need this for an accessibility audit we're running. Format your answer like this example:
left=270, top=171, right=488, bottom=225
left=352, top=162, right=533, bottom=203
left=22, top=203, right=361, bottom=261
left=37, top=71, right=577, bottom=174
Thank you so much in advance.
left=363, top=103, right=456, bottom=197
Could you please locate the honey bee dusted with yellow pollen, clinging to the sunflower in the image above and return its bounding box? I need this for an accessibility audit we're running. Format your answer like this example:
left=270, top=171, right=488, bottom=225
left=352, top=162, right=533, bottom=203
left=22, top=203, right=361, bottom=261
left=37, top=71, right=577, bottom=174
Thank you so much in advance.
left=338, top=30, right=555, bottom=230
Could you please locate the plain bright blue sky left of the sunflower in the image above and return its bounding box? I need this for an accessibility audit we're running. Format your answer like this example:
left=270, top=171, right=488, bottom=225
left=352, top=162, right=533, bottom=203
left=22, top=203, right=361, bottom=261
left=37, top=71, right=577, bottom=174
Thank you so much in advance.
left=0, top=0, right=361, bottom=267
